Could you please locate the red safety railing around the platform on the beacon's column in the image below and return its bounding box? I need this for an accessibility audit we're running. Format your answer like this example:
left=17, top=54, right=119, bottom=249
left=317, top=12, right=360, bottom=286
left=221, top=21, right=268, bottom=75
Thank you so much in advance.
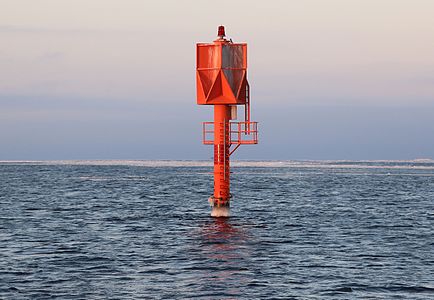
left=202, top=122, right=258, bottom=145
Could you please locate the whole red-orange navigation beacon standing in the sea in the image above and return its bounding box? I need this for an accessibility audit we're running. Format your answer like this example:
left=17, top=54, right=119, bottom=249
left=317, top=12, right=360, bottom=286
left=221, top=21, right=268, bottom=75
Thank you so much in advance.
left=196, top=26, right=258, bottom=217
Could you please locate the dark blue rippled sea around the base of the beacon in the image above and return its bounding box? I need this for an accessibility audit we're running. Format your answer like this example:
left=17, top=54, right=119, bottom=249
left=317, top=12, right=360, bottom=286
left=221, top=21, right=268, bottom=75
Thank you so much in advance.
left=0, top=160, right=434, bottom=299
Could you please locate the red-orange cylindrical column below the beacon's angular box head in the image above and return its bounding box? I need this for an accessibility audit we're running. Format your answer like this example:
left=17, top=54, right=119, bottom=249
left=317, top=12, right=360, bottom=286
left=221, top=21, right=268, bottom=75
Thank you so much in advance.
left=213, top=105, right=231, bottom=207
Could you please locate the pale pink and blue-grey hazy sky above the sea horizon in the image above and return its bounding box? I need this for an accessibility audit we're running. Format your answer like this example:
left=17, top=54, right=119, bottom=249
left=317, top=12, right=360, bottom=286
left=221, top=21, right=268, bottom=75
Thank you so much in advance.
left=0, top=0, right=434, bottom=160
